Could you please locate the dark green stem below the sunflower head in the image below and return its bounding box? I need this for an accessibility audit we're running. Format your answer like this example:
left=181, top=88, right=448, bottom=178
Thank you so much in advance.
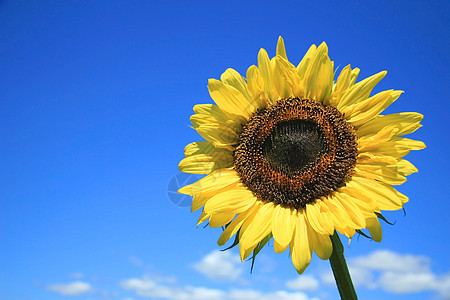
left=330, top=230, right=358, bottom=300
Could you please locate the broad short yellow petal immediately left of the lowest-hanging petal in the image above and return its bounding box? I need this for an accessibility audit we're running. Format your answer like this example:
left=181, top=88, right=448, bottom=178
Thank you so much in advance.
left=272, top=205, right=295, bottom=251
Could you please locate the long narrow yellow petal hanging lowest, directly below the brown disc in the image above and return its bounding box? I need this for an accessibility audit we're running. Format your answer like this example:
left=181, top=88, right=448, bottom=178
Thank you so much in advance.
left=290, top=211, right=312, bottom=274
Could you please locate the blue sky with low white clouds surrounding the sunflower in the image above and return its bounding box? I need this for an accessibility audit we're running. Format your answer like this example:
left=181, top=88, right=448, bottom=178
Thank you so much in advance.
left=0, top=1, right=450, bottom=300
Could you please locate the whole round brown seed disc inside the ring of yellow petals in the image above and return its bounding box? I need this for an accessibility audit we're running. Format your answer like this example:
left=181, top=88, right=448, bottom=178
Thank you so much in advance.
left=234, top=98, right=357, bottom=209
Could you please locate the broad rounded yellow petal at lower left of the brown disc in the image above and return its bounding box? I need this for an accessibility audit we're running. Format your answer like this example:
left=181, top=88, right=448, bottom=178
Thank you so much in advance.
left=205, top=187, right=256, bottom=214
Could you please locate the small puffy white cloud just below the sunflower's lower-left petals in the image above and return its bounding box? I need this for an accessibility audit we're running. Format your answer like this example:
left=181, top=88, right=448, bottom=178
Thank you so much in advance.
left=193, top=250, right=242, bottom=281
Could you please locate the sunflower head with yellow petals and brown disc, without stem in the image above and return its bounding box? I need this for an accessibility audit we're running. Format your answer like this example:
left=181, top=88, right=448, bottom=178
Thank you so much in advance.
left=179, top=37, right=425, bottom=273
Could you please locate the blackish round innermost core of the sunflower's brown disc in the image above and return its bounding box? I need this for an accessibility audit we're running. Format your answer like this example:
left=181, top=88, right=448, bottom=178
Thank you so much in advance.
left=262, top=120, right=328, bottom=175
